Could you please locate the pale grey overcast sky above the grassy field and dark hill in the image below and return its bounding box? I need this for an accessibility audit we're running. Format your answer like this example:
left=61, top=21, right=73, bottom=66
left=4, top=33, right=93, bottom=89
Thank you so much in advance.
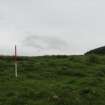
left=0, top=0, right=105, bottom=56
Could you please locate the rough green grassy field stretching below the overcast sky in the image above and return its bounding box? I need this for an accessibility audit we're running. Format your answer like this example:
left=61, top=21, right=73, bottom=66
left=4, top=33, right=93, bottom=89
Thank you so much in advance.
left=0, top=55, right=105, bottom=105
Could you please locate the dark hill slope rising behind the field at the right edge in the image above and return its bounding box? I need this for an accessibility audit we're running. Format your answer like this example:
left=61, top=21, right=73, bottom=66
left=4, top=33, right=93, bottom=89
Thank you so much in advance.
left=85, top=46, right=105, bottom=55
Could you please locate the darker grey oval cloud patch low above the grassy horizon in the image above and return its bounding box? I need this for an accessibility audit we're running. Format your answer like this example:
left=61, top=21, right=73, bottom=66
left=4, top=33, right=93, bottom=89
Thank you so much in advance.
left=22, top=35, right=69, bottom=50
